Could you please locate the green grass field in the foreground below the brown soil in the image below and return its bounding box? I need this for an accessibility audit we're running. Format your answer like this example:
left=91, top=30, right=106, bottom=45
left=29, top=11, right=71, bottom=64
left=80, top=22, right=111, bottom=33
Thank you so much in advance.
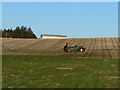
left=2, top=55, right=118, bottom=88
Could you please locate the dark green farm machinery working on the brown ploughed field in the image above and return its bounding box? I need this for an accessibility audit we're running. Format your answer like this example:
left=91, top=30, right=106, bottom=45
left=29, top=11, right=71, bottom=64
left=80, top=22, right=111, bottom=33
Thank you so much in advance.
left=64, top=43, right=86, bottom=52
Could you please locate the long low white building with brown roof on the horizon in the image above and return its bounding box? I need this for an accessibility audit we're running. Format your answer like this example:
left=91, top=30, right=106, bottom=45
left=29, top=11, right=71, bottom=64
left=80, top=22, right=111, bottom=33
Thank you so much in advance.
left=41, top=34, right=67, bottom=39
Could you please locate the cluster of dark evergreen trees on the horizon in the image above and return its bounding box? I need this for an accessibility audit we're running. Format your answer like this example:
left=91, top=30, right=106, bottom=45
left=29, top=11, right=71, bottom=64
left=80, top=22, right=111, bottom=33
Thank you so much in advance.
left=2, top=26, right=37, bottom=38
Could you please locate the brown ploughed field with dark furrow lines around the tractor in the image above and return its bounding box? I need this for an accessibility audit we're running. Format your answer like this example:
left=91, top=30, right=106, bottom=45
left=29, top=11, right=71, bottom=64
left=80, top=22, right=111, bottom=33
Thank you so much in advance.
left=2, top=38, right=118, bottom=59
